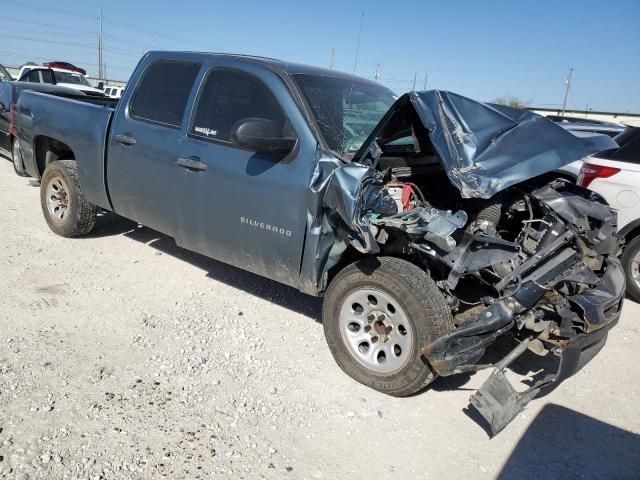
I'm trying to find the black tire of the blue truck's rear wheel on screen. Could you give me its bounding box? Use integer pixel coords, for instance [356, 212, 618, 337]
[40, 160, 97, 237]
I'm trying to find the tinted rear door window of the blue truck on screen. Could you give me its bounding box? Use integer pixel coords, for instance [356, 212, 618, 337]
[130, 60, 201, 128]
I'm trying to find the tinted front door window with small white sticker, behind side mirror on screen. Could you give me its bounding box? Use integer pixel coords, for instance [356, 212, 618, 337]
[189, 69, 292, 143]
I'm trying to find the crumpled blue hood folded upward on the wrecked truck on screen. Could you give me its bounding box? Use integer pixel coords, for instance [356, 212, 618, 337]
[356, 90, 616, 198]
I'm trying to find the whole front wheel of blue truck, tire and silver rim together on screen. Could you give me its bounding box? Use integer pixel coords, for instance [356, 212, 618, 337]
[322, 257, 454, 397]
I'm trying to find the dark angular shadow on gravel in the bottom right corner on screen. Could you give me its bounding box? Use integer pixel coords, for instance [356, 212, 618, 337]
[497, 403, 640, 480]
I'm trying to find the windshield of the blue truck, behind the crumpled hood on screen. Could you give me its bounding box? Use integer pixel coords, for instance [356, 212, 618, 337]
[293, 74, 395, 156]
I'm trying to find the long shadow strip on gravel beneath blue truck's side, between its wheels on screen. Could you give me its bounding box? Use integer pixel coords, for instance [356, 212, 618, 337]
[84, 213, 322, 322]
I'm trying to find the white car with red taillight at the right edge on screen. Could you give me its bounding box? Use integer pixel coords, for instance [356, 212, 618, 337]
[578, 127, 640, 302]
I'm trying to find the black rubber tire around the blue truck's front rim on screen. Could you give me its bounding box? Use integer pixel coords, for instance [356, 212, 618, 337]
[322, 257, 455, 397]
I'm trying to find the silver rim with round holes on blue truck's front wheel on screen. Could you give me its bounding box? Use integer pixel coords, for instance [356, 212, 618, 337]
[339, 288, 414, 374]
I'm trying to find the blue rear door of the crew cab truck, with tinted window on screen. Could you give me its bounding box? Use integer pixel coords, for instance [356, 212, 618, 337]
[107, 60, 200, 236]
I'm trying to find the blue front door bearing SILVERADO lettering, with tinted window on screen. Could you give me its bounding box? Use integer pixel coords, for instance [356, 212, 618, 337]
[178, 65, 313, 286]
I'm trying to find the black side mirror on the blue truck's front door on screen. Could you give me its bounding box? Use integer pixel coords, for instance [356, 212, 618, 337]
[231, 118, 297, 154]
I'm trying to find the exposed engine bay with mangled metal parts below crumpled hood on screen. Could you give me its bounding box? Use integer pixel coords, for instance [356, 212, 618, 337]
[370, 169, 618, 352]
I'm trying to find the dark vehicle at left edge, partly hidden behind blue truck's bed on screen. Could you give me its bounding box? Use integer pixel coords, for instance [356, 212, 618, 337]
[0, 82, 85, 176]
